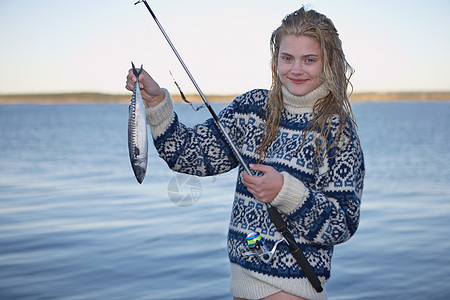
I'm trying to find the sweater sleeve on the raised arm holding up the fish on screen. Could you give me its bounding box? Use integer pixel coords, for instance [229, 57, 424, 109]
[147, 91, 238, 176]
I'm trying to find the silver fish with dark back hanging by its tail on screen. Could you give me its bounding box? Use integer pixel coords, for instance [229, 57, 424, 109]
[128, 63, 148, 183]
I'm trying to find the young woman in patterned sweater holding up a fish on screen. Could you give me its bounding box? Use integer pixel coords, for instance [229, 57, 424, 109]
[126, 8, 365, 299]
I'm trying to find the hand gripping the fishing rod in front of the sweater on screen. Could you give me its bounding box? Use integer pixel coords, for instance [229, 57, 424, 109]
[243, 164, 284, 203]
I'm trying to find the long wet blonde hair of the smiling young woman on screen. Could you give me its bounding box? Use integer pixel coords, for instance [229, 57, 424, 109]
[259, 7, 356, 161]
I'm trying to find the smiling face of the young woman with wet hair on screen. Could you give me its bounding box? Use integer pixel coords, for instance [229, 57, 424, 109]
[278, 35, 322, 96]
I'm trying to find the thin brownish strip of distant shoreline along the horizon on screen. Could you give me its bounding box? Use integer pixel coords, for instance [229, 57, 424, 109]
[0, 92, 450, 104]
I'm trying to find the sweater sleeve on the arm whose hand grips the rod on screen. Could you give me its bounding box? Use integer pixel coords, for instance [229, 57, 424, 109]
[272, 122, 365, 246]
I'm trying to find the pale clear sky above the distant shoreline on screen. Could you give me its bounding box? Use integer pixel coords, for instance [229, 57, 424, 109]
[0, 0, 450, 95]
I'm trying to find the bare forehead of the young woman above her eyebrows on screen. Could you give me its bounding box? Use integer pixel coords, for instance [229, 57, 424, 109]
[280, 34, 320, 55]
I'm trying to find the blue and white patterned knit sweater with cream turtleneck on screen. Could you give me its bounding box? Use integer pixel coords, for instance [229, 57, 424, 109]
[147, 85, 365, 299]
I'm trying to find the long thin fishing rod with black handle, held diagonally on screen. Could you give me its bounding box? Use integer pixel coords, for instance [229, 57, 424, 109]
[135, 0, 323, 293]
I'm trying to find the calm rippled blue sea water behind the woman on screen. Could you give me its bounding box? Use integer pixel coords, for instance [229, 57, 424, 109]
[0, 101, 450, 300]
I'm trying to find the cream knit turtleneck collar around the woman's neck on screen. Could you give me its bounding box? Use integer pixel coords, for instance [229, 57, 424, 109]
[281, 84, 330, 113]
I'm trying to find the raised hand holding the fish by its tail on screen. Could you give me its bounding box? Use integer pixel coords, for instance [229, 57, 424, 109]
[125, 69, 164, 107]
